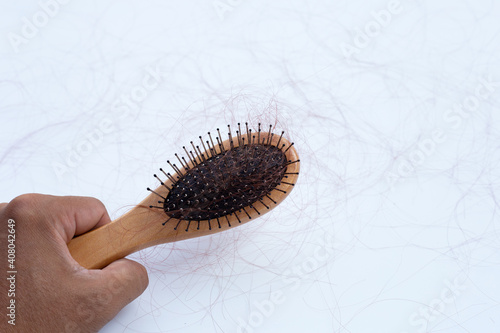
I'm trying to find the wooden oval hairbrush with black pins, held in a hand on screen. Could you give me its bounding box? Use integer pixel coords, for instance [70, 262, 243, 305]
[68, 123, 300, 269]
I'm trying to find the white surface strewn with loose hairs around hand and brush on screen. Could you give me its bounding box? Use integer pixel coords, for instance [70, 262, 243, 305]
[0, 0, 500, 333]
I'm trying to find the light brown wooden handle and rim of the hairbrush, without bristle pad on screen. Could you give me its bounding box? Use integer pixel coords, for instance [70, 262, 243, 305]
[68, 133, 300, 269]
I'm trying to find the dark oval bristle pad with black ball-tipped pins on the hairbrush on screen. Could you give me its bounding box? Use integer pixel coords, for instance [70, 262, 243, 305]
[152, 123, 299, 231]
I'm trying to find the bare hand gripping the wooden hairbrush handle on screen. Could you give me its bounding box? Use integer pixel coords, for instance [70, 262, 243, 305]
[0, 194, 148, 333]
